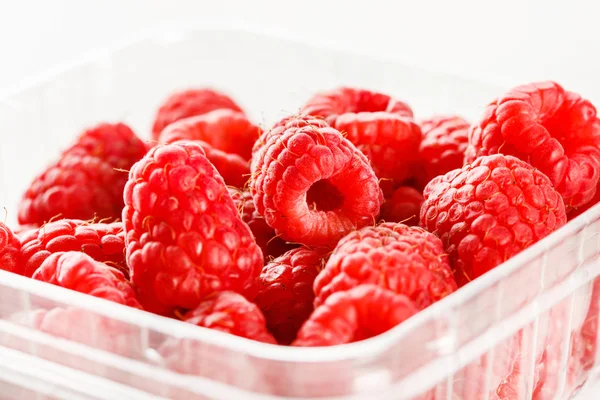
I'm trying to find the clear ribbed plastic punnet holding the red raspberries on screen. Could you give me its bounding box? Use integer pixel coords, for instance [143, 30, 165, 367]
[0, 28, 600, 400]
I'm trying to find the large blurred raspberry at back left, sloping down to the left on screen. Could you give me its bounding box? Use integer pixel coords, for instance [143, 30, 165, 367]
[19, 123, 147, 226]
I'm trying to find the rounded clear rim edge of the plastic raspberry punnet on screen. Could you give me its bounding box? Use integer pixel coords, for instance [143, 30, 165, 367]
[0, 21, 600, 363]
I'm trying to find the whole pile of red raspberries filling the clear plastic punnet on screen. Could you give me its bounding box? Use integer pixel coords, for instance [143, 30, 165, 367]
[0, 82, 600, 399]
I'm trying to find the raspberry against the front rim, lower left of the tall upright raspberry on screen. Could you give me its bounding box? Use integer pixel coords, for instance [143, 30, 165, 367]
[32, 251, 141, 308]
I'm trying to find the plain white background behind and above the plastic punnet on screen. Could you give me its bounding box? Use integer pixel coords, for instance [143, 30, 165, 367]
[0, 0, 600, 399]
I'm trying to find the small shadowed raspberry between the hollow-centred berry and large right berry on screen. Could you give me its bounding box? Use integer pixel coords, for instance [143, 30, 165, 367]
[379, 186, 423, 226]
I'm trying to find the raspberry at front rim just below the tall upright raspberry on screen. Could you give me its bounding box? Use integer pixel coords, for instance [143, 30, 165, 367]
[182, 291, 277, 344]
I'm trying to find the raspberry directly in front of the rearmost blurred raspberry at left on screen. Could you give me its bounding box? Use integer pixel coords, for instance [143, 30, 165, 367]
[159, 109, 261, 160]
